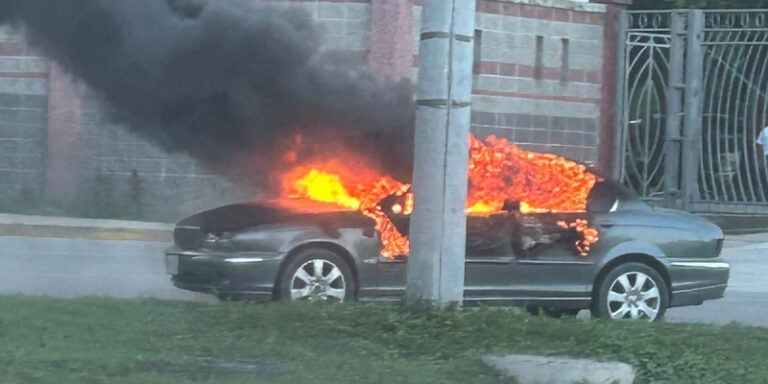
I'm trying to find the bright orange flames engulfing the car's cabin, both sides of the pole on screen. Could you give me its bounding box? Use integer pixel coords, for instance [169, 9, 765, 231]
[283, 136, 598, 258]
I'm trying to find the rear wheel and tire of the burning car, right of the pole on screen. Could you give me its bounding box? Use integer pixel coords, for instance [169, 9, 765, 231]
[591, 263, 669, 321]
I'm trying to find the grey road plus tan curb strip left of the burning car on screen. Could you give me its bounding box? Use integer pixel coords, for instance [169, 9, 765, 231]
[0, 214, 207, 300]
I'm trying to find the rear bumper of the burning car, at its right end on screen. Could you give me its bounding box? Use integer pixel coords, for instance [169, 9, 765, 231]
[667, 258, 731, 307]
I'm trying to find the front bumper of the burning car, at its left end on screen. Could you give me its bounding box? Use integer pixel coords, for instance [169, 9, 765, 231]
[165, 247, 285, 300]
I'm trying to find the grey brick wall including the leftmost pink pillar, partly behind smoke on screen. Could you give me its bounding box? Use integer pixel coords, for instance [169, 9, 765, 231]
[0, 0, 370, 221]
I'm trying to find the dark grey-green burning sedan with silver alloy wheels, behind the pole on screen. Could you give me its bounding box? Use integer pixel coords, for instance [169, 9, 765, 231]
[166, 182, 730, 320]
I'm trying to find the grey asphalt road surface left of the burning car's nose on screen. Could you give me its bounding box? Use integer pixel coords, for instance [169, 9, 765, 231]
[0, 236, 212, 300]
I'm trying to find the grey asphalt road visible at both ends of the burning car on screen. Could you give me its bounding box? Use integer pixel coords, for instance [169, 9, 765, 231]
[0, 236, 768, 326]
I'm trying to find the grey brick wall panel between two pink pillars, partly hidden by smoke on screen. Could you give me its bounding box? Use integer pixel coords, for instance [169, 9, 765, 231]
[68, 1, 370, 220]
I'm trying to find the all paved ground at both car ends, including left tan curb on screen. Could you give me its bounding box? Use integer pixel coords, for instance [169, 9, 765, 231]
[0, 214, 768, 326]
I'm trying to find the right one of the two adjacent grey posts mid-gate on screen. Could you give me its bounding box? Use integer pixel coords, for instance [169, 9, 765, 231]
[681, 10, 704, 210]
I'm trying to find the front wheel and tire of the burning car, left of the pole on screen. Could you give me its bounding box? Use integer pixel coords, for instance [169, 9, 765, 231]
[278, 248, 355, 302]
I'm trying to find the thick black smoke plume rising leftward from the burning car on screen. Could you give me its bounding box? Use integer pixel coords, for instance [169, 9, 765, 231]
[0, 0, 414, 186]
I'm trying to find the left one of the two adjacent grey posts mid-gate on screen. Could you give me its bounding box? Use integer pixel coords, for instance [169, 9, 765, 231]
[664, 12, 686, 208]
